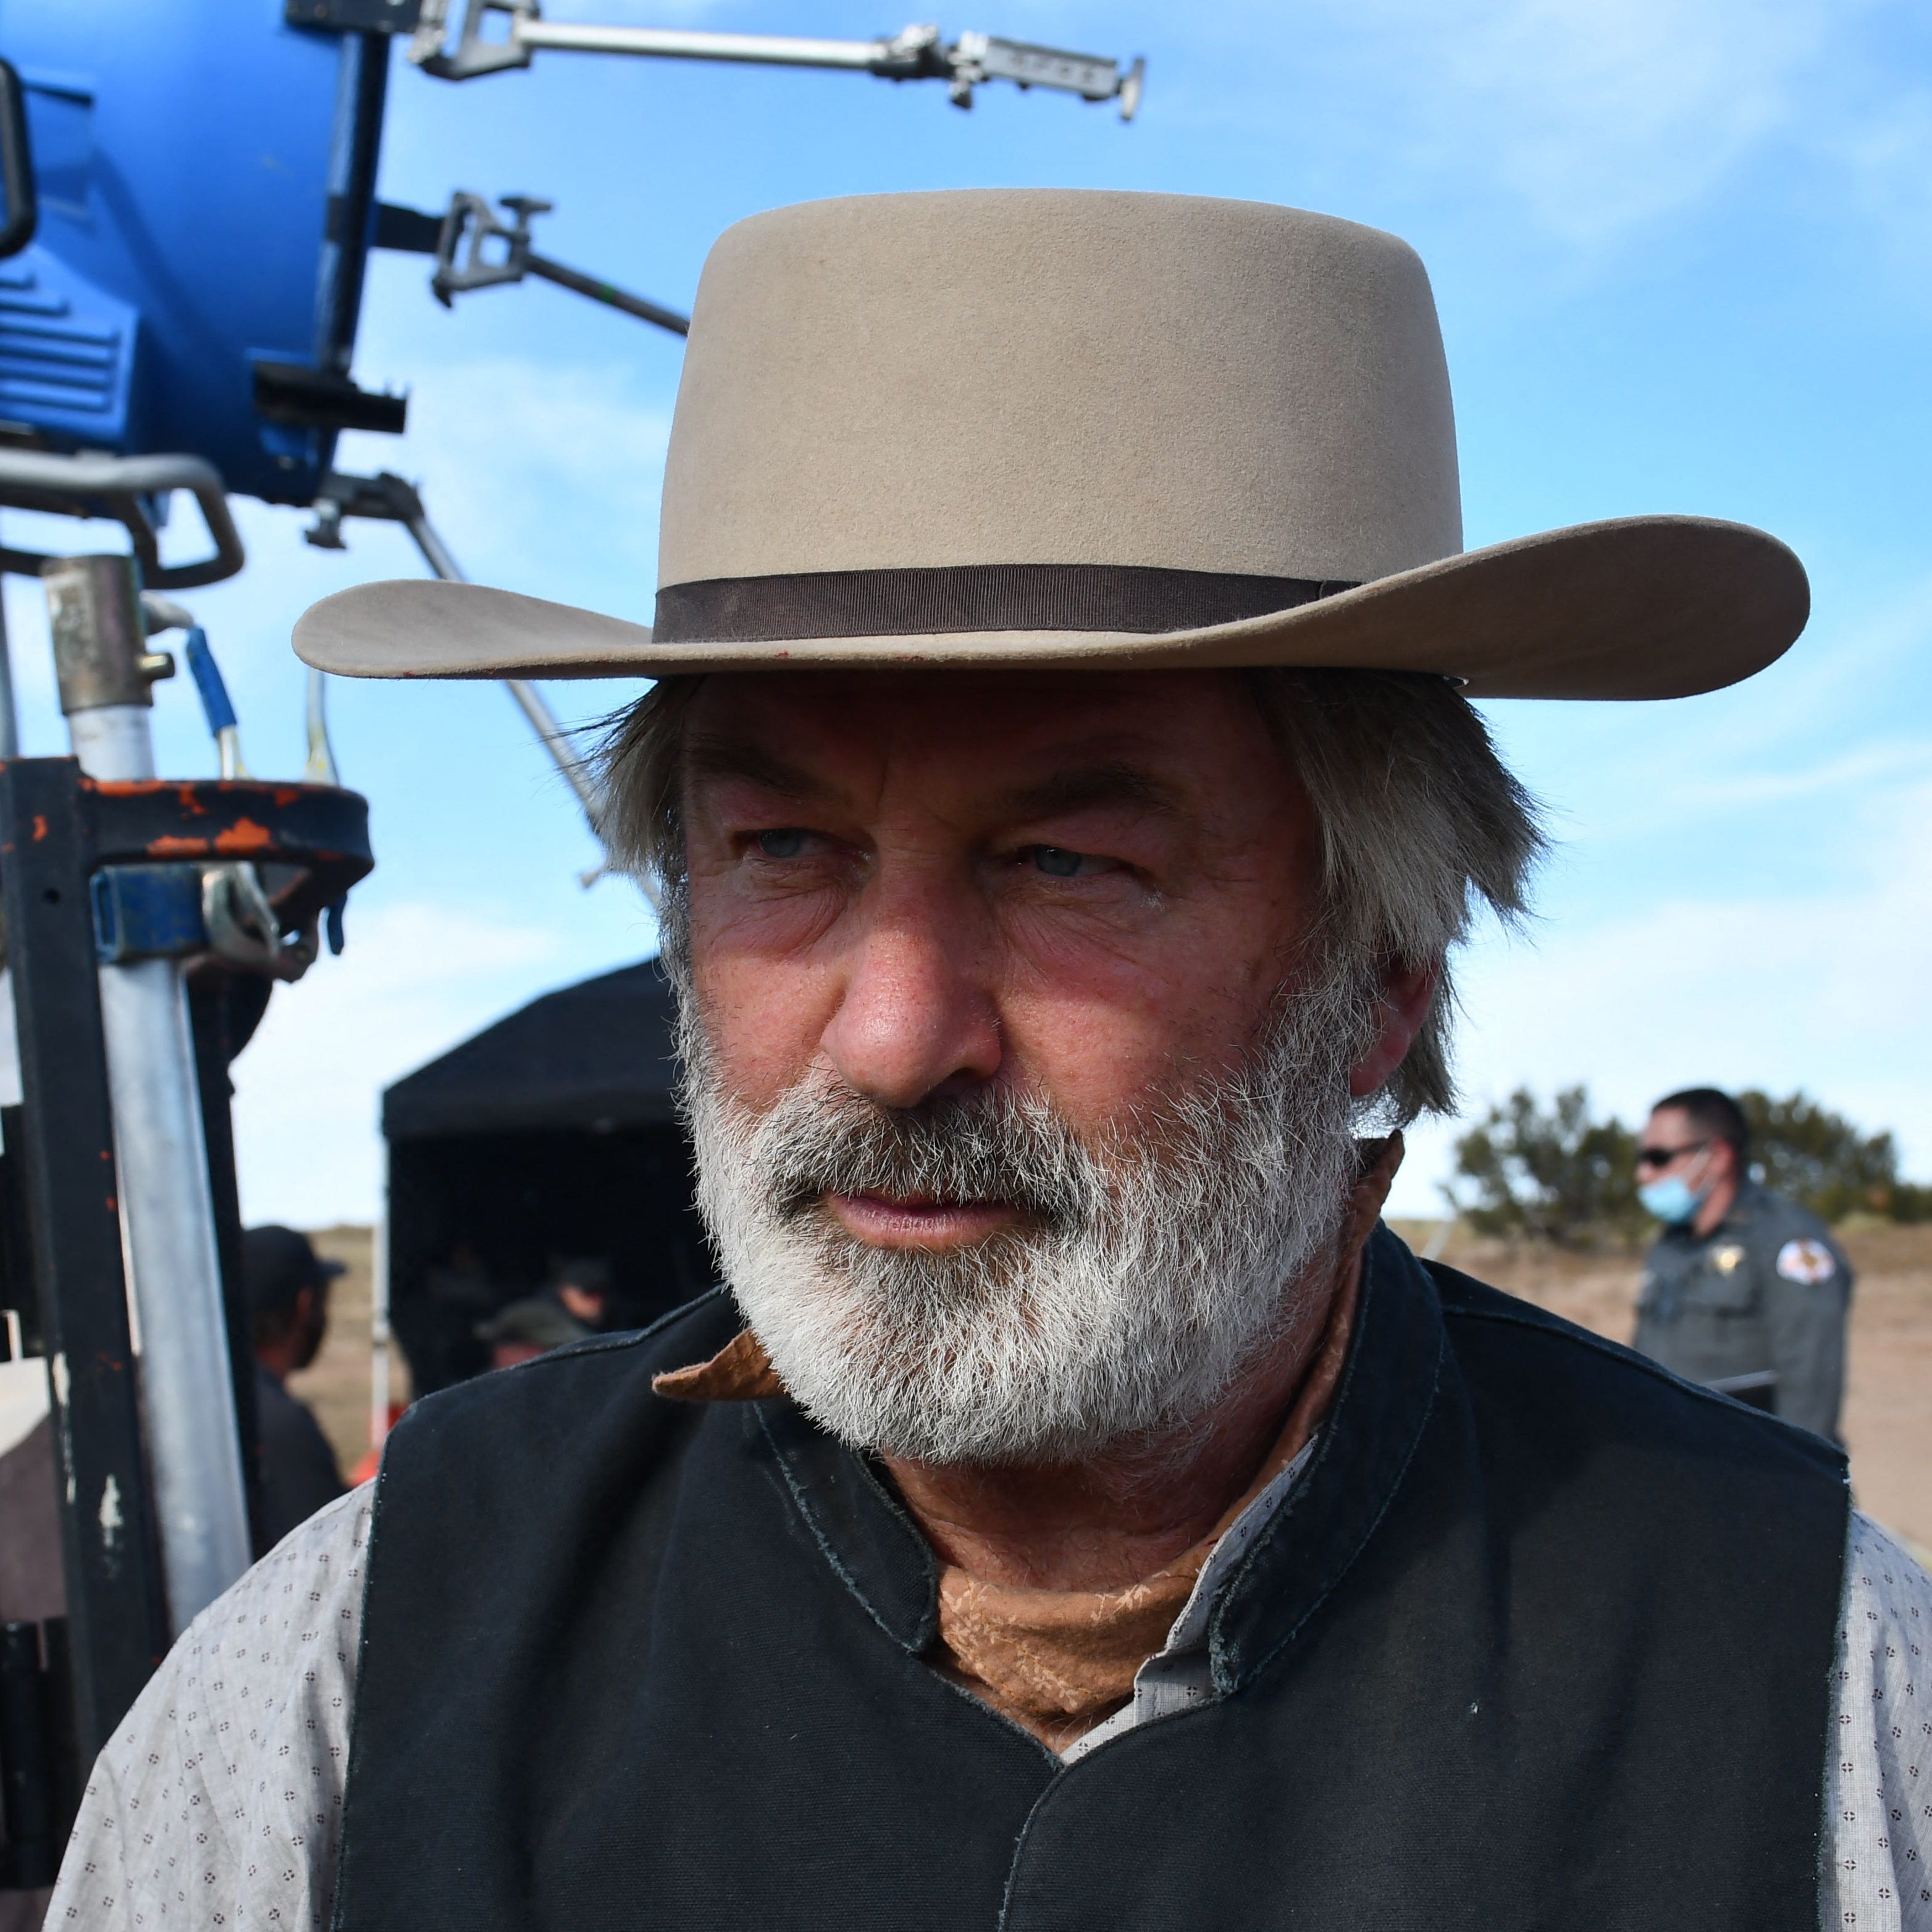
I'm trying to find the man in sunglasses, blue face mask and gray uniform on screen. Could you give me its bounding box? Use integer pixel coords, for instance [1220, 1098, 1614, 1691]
[1636, 1088, 1853, 1441]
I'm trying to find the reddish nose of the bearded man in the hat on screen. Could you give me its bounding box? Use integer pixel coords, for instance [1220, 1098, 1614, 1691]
[821, 881, 1001, 1107]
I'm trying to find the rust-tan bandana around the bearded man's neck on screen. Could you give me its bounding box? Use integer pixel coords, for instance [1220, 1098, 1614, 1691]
[651, 1134, 1403, 1750]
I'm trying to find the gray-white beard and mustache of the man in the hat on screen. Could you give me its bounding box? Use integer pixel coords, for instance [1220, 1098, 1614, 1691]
[680, 974, 1370, 1464]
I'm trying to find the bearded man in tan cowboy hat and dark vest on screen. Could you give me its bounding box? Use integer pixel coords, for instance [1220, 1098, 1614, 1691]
[54, 191, 1932, 1932]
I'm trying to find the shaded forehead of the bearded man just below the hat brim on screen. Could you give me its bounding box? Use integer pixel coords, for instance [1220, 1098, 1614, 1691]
[684, 670, 1285, 805]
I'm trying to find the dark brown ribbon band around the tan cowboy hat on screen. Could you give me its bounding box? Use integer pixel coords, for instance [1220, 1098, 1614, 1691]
[651, 564, 1354, 644]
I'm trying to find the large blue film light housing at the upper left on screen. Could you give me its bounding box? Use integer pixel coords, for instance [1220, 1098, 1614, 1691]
[0, 0, 388, 504]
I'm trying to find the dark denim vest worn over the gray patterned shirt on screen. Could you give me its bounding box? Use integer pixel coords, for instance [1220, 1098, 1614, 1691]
[336, 1231, 1847, 1932]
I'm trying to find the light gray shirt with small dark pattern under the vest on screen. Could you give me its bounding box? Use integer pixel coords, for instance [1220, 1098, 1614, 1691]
[46, 1464, 1932, 1932]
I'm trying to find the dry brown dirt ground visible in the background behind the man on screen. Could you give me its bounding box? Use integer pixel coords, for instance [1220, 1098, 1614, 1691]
[290, 1221, 1932, 1553]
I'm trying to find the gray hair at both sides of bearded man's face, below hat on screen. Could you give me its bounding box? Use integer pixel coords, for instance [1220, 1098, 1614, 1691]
[597, 668, 1545, 1127]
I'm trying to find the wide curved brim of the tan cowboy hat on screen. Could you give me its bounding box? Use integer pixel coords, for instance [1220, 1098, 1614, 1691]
[296, 516, 1810, 699]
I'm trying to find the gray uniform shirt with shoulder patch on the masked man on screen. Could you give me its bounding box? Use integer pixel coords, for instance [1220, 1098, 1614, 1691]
[1636, 1184, 1853, 1441]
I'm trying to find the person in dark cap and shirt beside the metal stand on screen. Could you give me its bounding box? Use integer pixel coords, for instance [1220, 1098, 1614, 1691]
[242, 1227, 344, 1545]
